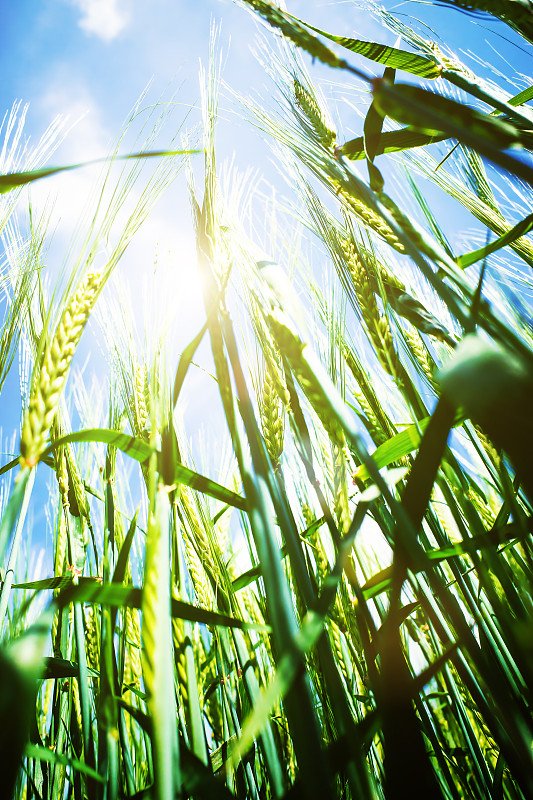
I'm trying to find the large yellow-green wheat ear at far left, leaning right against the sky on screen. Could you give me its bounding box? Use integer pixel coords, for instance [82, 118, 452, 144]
[20, 273, 104, 467]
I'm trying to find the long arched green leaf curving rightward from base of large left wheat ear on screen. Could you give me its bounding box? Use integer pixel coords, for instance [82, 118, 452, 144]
[40, 428, 246, 511]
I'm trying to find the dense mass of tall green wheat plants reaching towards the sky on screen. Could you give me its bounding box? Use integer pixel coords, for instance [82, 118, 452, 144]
[0, 0, 533, 800]
